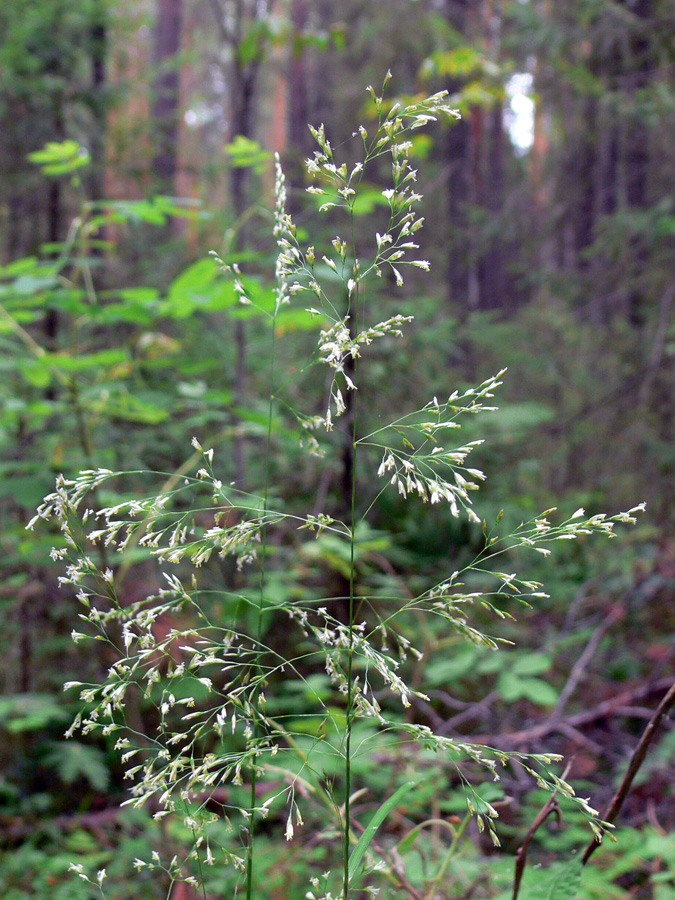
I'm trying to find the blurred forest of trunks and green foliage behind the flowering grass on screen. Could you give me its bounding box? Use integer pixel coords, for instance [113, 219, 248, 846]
[0, 0, 675, 900]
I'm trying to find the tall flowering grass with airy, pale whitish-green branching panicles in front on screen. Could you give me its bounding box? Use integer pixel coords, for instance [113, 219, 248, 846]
[29, 75, 640, 900]
